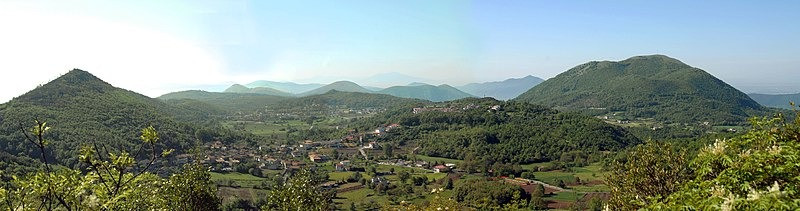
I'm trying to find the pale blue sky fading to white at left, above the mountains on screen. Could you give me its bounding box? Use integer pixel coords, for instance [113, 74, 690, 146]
[0, 0, 800, 102]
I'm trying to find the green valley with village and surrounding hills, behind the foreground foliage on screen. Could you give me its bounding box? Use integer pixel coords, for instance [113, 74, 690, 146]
[0, 55, 788, 210]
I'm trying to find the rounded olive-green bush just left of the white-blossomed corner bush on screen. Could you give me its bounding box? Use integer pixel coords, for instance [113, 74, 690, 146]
[605, 141, 691, 210]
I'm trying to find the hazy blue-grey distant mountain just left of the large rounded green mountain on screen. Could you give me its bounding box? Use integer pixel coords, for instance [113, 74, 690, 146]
[457, 75, 544, 100]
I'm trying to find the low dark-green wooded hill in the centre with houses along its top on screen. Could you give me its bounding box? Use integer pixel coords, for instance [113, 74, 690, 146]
[360, 98, 642, 163]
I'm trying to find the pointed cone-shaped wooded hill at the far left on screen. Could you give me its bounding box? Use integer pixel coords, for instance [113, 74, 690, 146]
[0, 69, 202, 170]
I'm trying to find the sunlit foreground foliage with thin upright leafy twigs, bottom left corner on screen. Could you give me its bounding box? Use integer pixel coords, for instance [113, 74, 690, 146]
[0, 121, 219, 210]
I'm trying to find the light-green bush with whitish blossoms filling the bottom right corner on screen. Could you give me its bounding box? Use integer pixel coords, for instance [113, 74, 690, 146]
[649, 111, 800, 210]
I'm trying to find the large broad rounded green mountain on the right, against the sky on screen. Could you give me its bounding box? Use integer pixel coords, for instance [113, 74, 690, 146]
[515, 55, 767, 124]
